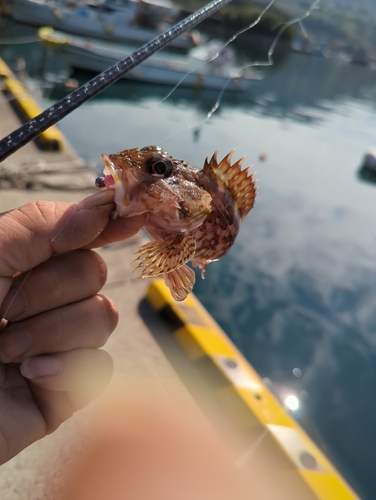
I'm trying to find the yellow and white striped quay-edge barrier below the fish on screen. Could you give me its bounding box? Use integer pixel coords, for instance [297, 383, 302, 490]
[147, 279, 358, 500]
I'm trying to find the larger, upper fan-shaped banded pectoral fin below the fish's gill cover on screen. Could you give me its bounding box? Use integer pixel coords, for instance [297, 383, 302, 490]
[133, 233, 196, 278]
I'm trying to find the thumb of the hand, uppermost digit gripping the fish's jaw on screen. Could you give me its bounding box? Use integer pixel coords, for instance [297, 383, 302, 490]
[0, 190, 113, 304]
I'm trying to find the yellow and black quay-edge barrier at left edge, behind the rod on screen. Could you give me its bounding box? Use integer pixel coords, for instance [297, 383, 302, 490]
[0, 58, 64, 151]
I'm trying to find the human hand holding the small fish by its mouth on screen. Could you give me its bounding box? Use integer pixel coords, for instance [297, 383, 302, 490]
[0, 191, 145, 464]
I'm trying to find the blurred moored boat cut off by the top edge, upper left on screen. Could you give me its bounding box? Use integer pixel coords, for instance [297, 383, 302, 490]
[9, 0, 196, 50]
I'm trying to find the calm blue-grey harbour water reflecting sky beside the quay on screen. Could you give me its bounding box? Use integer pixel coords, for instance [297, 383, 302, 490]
[0, 16, 376, 499]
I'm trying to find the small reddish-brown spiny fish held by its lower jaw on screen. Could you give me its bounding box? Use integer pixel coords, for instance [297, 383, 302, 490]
[96, 146, 256, 300]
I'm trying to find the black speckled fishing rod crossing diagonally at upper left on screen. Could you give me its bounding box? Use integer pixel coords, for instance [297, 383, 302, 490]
[0, 0, 231, 162]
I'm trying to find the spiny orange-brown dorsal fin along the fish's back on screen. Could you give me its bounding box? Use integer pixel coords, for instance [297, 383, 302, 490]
[204, 149, 257, 219]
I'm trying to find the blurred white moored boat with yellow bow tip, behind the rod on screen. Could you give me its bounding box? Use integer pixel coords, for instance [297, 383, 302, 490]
[39, 28, 260, 91]
